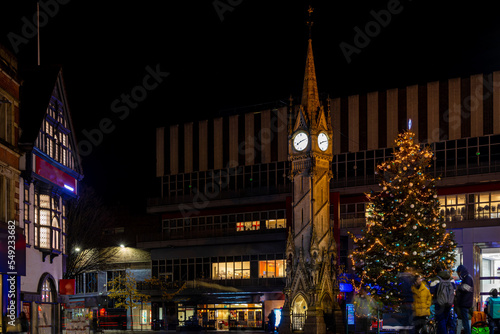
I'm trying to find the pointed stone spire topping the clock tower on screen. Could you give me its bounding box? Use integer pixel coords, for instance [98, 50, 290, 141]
[301, 6, 319, 115]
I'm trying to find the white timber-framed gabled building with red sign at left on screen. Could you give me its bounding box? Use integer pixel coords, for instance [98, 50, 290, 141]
[19, 67, 83, 333]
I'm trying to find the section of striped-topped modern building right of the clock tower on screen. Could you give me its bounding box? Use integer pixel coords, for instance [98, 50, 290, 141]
[331, 72, 500, 308]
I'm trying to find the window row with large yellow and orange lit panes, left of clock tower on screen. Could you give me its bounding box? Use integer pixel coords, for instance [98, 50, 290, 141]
[152, 254, 286, 282]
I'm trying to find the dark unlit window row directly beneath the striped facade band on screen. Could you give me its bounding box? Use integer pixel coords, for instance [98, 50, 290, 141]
[163, 135, 500, 197]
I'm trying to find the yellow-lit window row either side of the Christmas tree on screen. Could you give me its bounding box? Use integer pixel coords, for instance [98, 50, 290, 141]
[340, 191, 500, 227]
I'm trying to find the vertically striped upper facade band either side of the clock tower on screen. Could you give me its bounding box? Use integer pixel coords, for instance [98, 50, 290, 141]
[156, 72, 500, 183]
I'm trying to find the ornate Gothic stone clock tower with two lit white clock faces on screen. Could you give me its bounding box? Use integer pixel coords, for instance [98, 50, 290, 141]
[280, 8, 343, 333]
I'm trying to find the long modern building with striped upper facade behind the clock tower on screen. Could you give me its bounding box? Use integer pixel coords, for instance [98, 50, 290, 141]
[138, 36, 500, 329]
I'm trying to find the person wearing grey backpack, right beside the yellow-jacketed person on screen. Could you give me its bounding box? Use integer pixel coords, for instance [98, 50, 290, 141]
[430, 267, 456, 334]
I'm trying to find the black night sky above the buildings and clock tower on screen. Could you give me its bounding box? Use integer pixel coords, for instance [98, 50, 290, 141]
[0, 0, 500, 211]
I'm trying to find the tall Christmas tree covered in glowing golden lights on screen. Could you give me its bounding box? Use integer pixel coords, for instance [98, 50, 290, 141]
[351, 126, 456, 306]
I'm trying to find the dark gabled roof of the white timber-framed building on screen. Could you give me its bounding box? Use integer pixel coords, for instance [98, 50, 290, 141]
[19, 66, 83, 175]
